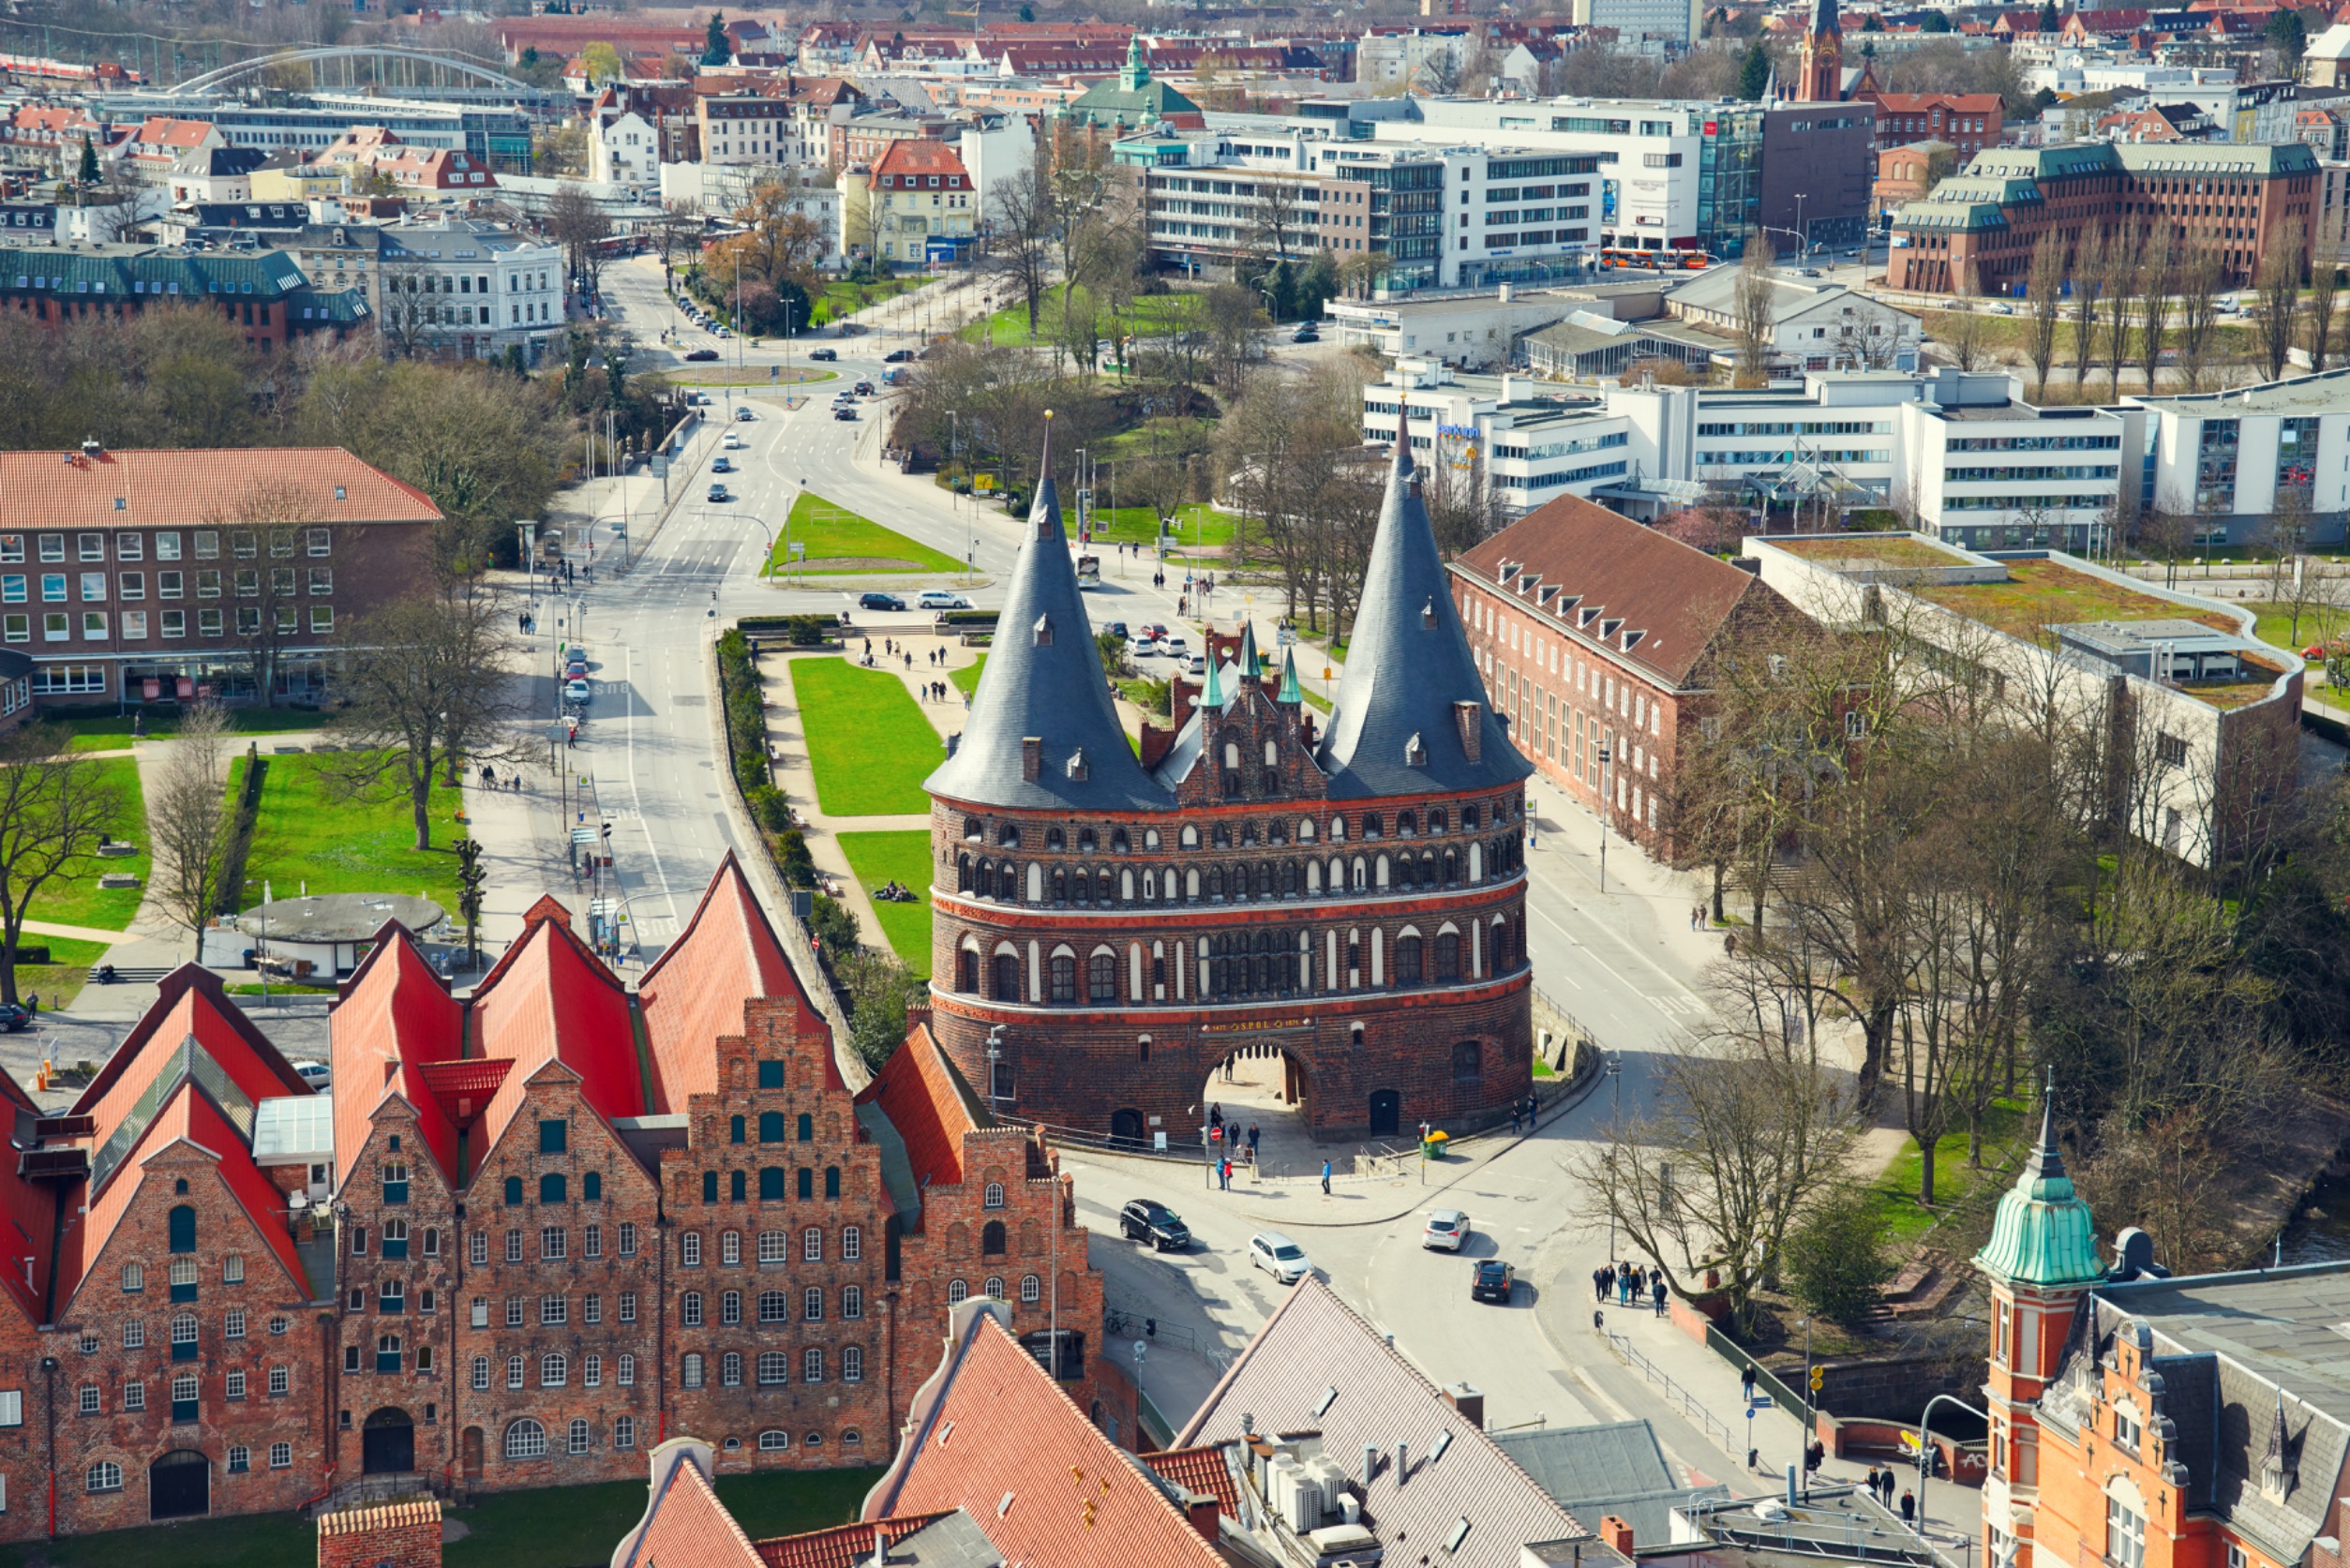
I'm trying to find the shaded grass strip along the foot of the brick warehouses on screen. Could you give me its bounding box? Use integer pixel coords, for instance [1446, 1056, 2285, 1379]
[0, 1470, 879, 1568]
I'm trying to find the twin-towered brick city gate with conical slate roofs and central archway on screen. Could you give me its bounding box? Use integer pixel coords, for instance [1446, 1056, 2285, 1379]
[928, 413, 1533, 1142]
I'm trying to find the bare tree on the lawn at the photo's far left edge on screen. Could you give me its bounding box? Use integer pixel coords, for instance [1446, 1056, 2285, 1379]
[0, 724, 125, 1002]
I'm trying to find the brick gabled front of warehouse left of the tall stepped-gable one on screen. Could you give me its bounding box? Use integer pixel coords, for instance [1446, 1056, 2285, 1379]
[448, 1065, 660, 1490]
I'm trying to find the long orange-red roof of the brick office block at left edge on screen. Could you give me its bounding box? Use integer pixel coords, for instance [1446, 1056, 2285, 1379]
[0, 447, 440, 529]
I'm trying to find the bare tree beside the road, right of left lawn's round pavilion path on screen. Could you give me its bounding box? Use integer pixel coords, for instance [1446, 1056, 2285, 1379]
[331, 578, 522, 848]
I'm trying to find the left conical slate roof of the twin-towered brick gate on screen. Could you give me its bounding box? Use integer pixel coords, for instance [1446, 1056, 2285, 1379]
[923, 438, 1175, 811]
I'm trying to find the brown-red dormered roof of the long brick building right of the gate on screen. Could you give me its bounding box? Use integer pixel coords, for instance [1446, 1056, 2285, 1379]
[1452, 496, 1781, 686]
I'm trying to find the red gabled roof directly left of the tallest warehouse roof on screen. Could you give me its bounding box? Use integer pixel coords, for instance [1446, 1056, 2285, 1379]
[472, 898, 644, 1150]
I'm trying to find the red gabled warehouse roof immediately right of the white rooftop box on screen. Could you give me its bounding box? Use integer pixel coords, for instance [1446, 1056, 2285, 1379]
[329, 921, 460, 1187]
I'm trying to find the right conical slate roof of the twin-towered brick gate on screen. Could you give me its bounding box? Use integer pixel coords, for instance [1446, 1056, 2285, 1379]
[1316, 409, 1534, 799]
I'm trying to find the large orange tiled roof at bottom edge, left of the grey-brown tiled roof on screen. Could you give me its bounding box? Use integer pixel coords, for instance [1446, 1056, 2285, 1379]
[865, 1303, 1224, 1568]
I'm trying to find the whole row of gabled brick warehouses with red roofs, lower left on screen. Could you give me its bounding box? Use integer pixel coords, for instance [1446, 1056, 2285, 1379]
[0, 860, 1135, 1540]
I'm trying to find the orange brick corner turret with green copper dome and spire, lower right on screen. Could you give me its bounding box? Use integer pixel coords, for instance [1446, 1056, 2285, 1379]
[1974, 1083, 2105, 1568]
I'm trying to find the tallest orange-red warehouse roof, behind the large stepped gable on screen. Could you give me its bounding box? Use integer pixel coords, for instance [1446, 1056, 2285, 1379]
[636, 851, 839, 1114]
